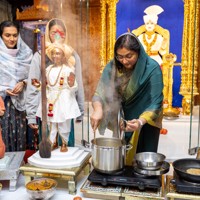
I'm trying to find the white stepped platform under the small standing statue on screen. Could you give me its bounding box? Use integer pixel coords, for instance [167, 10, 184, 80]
[28, 147, 90, 169]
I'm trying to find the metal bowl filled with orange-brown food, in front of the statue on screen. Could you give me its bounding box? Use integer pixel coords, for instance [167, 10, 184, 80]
[26, 178, 57, 200]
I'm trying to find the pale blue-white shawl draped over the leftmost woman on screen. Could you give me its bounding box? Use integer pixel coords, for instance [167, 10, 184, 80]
[0, 35, 32, 111]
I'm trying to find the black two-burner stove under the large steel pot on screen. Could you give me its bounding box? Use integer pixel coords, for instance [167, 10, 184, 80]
[88, 166, 162, 190]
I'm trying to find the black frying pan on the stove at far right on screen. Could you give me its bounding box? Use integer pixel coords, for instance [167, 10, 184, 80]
[172, 158, 200, 183]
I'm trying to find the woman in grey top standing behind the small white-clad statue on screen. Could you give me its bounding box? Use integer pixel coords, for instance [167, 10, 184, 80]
[26, 18, 84, 146]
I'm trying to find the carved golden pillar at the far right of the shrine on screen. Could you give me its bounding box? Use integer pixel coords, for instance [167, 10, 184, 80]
[180, 0, 199, 114]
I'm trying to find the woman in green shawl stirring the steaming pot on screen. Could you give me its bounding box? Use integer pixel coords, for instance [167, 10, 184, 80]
[90, 33, 163, 165]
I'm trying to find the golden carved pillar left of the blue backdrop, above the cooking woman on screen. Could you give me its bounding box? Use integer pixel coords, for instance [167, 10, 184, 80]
[100, 0, 119, 72]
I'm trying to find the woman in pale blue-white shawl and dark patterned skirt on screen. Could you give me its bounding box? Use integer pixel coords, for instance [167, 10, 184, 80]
[0, 21, 32, 151]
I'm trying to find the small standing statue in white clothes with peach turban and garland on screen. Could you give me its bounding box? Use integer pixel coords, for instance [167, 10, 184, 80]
[32, 43, 81, 152]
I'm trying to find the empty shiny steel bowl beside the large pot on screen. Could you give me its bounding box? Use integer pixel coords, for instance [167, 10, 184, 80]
[135, 152, 166, 170]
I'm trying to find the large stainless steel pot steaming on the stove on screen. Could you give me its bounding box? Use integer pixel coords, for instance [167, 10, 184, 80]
[91, 138, 130, 174]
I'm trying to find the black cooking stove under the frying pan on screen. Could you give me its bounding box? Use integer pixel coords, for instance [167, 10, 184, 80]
[171, 172, 200, 194]
